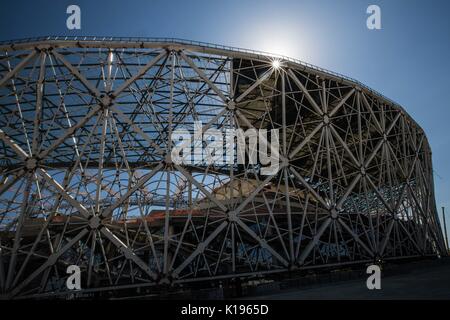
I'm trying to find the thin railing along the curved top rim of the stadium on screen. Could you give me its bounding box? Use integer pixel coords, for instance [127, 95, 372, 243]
[0, 36, 400, 107]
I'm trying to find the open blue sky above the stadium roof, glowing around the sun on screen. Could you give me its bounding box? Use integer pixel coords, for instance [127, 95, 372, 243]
[0, 0, 450, 240]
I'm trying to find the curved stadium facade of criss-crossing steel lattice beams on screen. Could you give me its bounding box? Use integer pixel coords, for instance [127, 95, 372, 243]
[0, 38, 445, 298]
